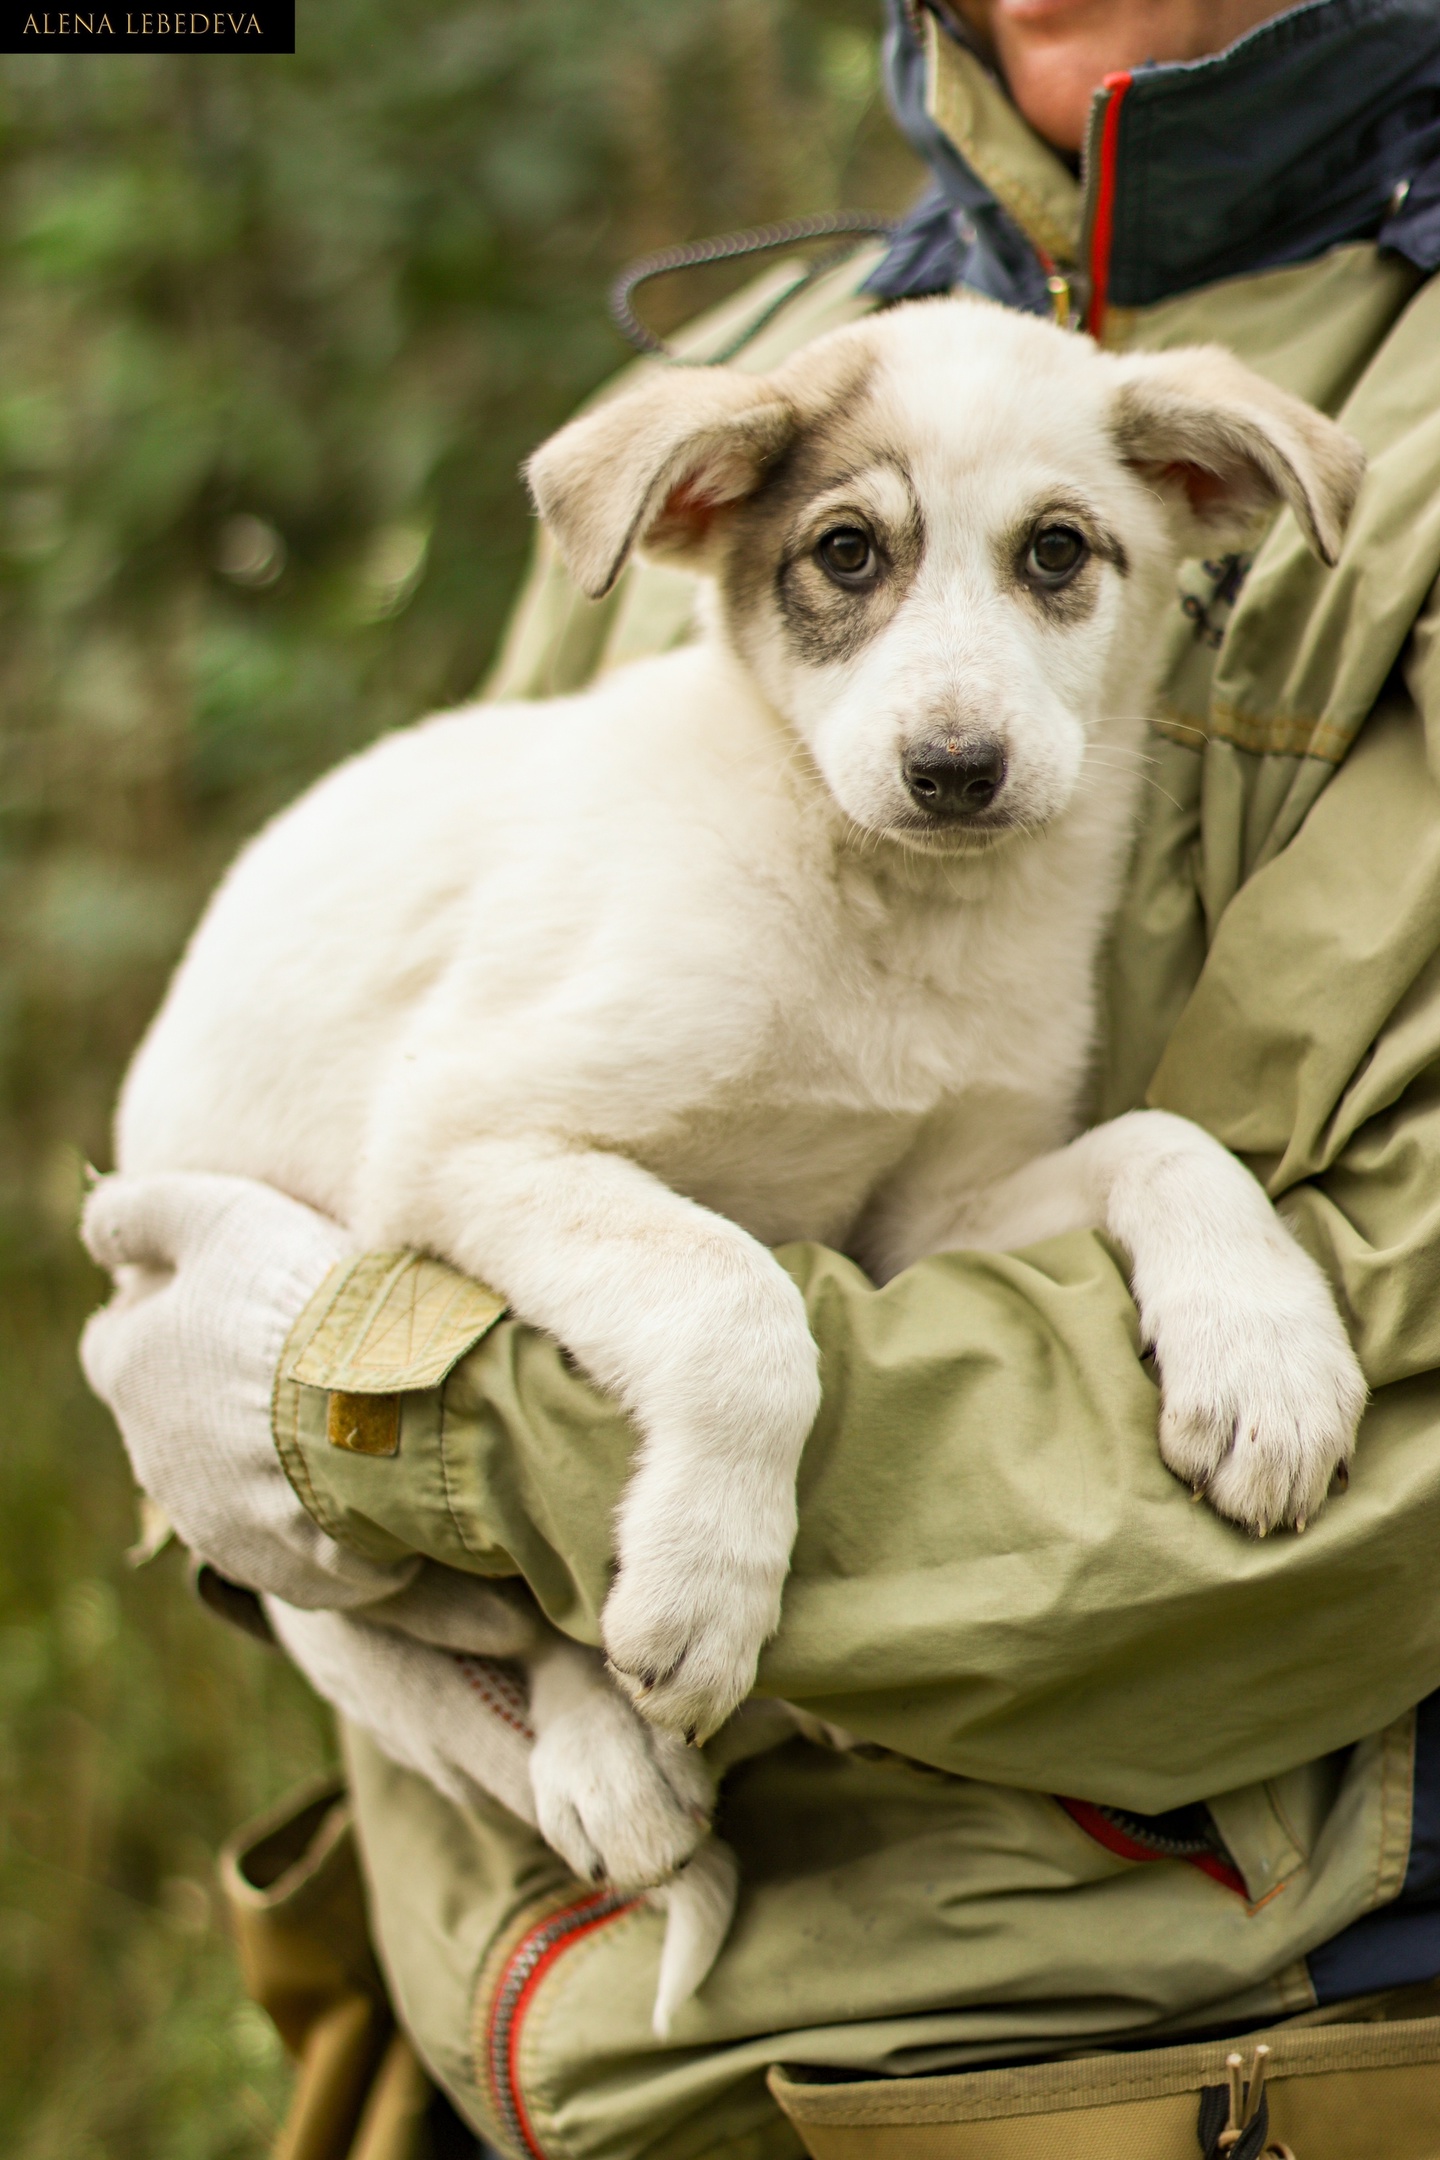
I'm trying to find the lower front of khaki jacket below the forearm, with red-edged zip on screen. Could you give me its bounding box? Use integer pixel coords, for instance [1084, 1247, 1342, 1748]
[348, 1730, 1434, 2160]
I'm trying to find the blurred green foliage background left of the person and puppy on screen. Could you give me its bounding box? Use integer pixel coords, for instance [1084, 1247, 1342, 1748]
[0, 0, 920, 2160]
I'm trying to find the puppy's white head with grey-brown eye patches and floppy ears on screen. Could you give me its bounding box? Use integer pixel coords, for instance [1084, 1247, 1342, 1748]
[529, 300, 1362, 851]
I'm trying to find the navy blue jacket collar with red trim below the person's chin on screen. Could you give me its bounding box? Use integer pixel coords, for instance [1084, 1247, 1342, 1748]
[870, 0, 1440, 313]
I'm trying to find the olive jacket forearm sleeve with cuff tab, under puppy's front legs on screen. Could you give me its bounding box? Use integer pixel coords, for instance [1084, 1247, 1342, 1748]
[276, 1175, 1440, 1810]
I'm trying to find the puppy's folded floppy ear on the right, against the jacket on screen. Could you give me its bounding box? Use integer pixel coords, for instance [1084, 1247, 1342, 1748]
[1112, 346, 1364, 562]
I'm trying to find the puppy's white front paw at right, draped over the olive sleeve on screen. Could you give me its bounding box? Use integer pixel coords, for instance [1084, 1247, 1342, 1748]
[1142, 1225, 1364, 1536]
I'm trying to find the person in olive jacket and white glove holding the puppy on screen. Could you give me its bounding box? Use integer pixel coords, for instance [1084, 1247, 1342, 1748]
[84, 0, 1440, 2160]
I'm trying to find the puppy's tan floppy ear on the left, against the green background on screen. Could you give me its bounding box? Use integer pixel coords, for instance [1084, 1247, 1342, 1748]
[525, 367, 797, 600]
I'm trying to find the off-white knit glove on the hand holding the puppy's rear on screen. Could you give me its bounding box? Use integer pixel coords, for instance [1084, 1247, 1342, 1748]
[80, 1173, 419, 1607]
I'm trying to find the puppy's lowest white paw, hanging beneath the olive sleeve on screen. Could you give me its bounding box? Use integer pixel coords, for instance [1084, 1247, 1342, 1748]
[529, 1689, 715, 1890]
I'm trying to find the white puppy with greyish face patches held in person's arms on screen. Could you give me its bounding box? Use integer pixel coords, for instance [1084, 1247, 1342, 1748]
[119, 300, 1364, 2013]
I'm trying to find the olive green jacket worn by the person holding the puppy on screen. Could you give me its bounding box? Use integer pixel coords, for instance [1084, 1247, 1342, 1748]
[264, 45, 1440, 2154]
